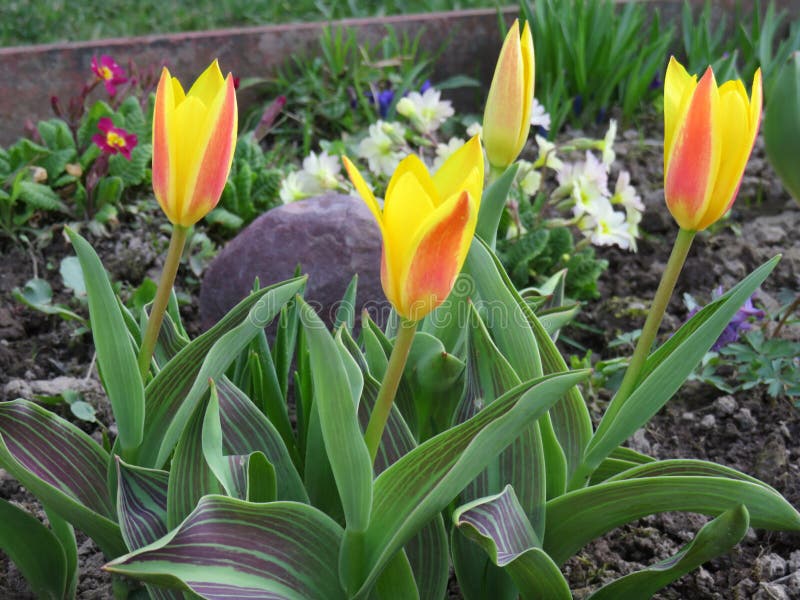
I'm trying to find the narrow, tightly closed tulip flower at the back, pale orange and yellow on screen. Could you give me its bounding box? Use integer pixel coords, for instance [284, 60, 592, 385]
[483, 21, 535, 170]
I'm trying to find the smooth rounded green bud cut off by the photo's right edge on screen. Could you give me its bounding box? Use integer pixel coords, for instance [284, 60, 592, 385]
[764, 52, 800, 202]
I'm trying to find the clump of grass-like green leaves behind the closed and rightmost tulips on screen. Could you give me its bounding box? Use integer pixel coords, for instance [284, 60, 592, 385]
[521, 0, 674, 136]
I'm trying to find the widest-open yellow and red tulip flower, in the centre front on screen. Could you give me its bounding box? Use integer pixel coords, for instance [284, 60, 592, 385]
[343, 136, 483, 321]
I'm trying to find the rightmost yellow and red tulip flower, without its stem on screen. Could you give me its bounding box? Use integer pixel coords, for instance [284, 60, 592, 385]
[664, 58, 762, 231]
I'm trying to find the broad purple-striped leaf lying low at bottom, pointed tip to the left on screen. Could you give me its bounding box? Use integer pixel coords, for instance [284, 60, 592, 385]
[104, 496, 345, 600]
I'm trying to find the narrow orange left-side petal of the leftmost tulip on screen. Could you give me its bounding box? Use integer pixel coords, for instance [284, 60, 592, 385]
[152, 67, 175, 221]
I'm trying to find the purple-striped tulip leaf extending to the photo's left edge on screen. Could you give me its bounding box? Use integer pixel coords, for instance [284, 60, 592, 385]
[0, 400, 126, 556]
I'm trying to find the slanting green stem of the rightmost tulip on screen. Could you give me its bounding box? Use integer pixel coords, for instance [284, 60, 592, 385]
[614, 229, 697, 406]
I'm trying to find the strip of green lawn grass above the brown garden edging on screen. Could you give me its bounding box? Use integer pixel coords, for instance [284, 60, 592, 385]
[0, 0, 498, 46]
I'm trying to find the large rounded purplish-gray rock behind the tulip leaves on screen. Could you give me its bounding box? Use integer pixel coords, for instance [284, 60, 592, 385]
[200, 194, 389, 328]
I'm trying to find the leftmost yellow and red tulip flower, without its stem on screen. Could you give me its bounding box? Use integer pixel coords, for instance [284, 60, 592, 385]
[153, 60, 238, 227]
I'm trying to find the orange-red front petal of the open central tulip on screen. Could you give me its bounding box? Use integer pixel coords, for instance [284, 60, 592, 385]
[396, 191, 478, 321]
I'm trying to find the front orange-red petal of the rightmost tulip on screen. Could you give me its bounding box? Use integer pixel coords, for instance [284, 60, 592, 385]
[664, 68, 722, 230]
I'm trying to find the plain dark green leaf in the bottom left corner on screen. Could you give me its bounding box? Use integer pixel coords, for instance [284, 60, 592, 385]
[0, 498, 71, 600]
